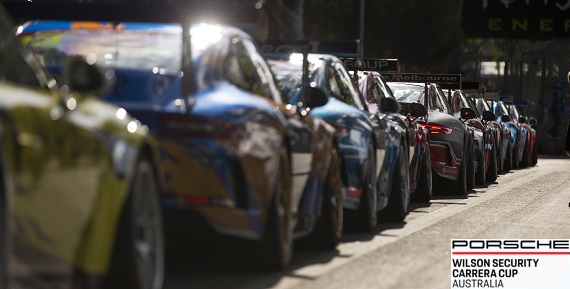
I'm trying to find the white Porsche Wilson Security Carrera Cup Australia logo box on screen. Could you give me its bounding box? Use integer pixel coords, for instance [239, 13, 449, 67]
[450, 239, 570, 289]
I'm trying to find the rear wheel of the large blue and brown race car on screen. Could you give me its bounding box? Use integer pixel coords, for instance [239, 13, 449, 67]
[261, 147, 293, 269]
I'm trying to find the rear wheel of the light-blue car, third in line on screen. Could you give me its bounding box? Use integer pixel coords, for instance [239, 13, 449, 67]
[355, 143, 378, 232]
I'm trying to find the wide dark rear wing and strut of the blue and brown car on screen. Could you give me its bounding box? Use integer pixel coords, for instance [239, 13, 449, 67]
[1, 0, 262, 109]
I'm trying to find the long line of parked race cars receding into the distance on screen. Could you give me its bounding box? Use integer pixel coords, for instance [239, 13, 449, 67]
[0, 2, 537, 288]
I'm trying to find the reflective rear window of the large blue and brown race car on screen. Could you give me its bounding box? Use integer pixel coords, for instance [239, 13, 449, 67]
[18, 21, 228, 104]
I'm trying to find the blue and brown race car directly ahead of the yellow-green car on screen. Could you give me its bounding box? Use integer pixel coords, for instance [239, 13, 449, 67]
[19, 9, 344, 268]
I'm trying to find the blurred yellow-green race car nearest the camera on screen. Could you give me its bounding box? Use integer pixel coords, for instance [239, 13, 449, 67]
[0, 6, 164, 288]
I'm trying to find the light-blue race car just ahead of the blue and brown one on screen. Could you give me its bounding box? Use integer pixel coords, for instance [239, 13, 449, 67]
[269, 54, 410, 230]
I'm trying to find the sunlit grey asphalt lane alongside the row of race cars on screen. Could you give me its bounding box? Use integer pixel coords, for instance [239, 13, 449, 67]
[165, 156, 570, 289]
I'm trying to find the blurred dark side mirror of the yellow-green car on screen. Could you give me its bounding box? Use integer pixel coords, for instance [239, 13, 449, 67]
[63, 56, 107, 96]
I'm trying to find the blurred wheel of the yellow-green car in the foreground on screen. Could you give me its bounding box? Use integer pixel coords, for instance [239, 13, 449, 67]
[104, 157, 165, 289]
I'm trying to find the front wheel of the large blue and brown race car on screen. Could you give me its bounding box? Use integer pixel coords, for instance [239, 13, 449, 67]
[305, 147, 344, 250]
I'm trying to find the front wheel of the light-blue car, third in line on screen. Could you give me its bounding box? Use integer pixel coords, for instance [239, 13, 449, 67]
[378, 144, 410, 222]
